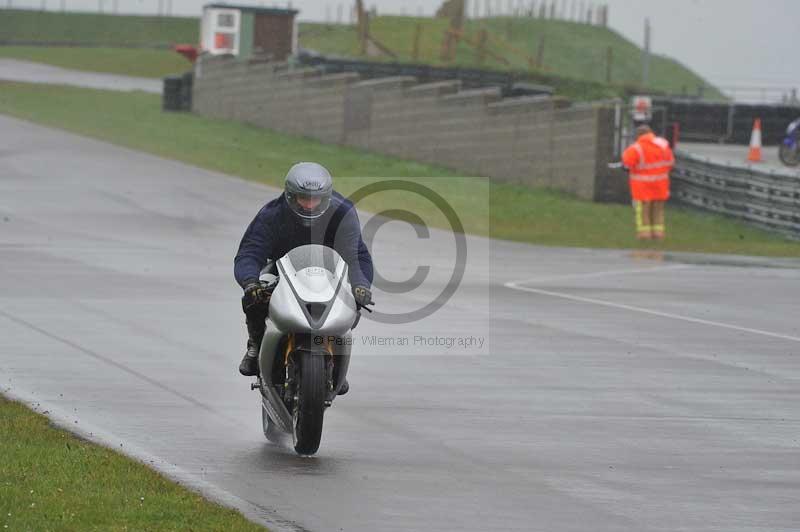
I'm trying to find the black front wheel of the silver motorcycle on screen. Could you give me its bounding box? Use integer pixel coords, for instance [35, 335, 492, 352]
[292, 352, 328, 456]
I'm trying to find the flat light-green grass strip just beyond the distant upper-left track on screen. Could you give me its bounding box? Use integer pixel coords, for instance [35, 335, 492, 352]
[0, 46, 192, 78]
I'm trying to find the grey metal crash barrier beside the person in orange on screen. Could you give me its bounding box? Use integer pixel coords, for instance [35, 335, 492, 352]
[672, 151, 800, 239]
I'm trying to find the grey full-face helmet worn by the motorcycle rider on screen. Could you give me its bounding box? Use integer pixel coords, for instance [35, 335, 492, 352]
[284, 163, 333, 227]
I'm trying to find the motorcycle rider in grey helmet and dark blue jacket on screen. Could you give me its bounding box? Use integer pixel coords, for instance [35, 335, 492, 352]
[234, 162, 373, 388]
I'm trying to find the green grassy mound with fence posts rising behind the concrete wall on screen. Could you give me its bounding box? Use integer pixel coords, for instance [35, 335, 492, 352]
[300, 16, 722, 99]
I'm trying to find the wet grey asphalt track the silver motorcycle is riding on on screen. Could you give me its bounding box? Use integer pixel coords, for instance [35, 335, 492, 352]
[0, 117, 800, 532]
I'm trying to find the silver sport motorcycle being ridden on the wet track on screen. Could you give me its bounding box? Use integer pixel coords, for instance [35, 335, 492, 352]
[252, 244, 361, 456]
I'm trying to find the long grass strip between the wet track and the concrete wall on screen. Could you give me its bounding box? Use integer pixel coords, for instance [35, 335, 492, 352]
[0, 83, 800, 257]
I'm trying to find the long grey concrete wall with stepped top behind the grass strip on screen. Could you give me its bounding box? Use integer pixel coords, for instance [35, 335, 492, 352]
[194, 56, 627, 201]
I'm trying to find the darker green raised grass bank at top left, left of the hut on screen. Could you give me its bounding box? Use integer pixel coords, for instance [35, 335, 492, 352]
[0, 9, 200, 47]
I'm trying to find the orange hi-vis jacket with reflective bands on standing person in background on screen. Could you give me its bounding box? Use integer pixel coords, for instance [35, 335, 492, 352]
[622, 133, 675, 201]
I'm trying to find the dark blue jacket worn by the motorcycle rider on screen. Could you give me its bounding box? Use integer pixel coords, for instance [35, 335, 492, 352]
[233, 192, 373, 287]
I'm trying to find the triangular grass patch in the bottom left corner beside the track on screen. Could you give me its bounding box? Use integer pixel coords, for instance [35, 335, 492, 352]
[0, 396, 265, 532]
